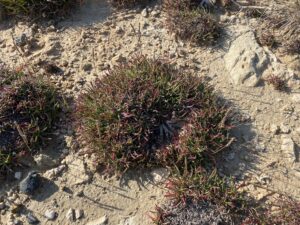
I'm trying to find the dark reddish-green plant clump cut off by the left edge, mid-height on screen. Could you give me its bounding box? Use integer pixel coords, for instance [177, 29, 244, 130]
[0, 67, 61, 173]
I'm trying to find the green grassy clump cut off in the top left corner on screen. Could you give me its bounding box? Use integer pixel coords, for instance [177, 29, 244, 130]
[0, 0, 83, 19]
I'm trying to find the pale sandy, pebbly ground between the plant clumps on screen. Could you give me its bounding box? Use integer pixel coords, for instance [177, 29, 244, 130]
[0, 0, 300, 225]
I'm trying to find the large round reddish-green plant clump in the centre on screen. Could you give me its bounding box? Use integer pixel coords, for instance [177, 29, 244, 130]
[76, 57, 231, 172]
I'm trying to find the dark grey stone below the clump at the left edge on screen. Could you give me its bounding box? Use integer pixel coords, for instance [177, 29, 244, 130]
[19, 171, 41, 195]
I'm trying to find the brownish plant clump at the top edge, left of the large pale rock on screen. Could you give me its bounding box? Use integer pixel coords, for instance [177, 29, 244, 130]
[163, 0, 221, 46]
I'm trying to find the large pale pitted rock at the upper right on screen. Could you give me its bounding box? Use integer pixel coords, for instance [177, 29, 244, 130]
[224, 31, 269, 87]
